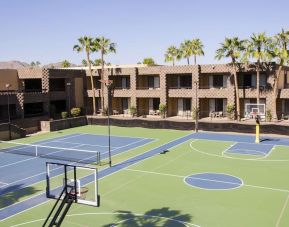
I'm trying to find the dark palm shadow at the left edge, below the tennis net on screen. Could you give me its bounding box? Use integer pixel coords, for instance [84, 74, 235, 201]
[0, 184, 40, 209]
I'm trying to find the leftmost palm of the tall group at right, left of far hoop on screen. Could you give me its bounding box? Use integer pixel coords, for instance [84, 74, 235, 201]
[215, 37, 245, 121]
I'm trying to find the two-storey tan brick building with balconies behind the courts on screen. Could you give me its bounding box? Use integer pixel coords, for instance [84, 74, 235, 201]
[0, 64, 289, 131]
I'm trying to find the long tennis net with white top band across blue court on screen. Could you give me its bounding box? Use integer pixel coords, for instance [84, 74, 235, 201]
[0, 141, 101, 165]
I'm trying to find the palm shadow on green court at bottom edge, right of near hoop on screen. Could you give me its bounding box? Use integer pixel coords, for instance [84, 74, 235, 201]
[103, 207, 192, 227]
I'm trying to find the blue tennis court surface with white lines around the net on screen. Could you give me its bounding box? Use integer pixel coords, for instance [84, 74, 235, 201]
[0, 134, 153, 195]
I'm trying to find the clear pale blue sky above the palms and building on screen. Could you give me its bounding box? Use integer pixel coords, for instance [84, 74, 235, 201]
[0, 0, 289, 64]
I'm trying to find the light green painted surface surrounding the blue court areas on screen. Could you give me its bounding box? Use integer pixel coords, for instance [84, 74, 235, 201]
[0, 126, 289, 227]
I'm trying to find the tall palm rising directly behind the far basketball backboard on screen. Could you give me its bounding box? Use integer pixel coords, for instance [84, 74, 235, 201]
[244, 32, 270, 104]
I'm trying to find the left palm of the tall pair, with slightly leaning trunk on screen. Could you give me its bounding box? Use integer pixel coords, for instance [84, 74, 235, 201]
[73, 36, 96, 115]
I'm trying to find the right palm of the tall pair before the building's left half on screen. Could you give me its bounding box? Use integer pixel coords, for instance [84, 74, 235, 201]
[93, 36, 116, 108]
